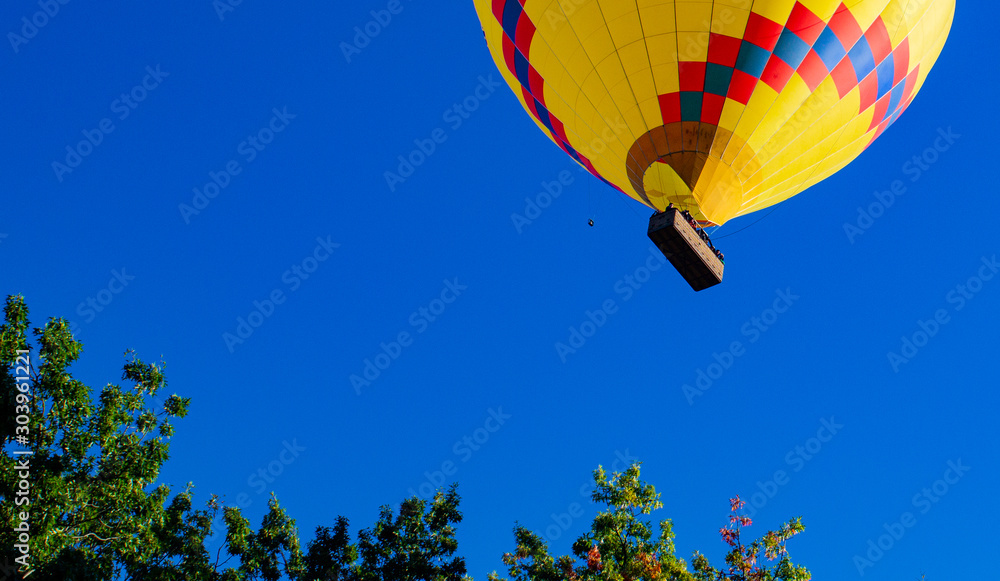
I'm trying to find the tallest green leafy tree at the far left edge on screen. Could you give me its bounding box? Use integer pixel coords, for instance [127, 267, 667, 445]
[0, 296, 195, 581]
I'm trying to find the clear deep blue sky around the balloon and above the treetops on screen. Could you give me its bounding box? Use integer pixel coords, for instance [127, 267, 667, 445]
[0, 0, 1000, 580]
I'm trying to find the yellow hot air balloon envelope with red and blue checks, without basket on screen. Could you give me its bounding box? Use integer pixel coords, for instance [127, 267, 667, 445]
[474, 0, 955, 224]
